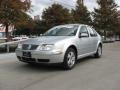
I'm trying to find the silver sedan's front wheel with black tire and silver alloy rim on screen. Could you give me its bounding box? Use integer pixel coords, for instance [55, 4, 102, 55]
[63, 48, 77, 70]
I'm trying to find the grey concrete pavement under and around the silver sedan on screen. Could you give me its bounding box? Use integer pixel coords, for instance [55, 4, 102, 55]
[0, 42, 120, 90]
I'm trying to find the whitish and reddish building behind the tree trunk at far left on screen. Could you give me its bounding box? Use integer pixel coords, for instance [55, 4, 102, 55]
[0, 24, 14, 38]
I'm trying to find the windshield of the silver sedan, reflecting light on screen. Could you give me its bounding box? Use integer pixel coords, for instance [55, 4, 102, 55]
[44, 25, 78, 36]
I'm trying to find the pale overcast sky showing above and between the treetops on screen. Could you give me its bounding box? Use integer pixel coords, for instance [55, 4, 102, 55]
[28, 0, 120, 16]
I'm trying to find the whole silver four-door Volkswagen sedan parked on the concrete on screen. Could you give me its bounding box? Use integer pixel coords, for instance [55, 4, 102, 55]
[16, 24, 102, 69]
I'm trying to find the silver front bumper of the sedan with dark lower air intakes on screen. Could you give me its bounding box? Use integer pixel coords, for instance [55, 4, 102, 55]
[16, 49, 64, 63]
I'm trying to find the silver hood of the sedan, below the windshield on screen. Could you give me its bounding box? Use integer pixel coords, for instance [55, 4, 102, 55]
[23, 36, 72, 45]
